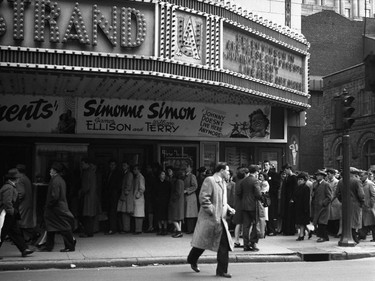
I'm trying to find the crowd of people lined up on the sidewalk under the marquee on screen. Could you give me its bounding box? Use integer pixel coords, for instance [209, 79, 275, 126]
[0, 158, 375, 256]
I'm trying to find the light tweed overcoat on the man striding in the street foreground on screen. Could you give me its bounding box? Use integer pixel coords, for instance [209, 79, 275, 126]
[191, 173, 234, 252]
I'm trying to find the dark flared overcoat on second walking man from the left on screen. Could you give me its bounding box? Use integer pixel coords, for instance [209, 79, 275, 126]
[44, 175, 74, 231]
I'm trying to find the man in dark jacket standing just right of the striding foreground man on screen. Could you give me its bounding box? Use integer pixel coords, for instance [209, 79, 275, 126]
[236, 165, 262, 251]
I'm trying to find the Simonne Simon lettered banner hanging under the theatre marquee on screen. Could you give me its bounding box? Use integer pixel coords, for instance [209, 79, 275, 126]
[77, 98, 271, 139]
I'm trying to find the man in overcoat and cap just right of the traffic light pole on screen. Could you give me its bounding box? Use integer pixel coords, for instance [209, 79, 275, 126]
[337, 167, 365, 244]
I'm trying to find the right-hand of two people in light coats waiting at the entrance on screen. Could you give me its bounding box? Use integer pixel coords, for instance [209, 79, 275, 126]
[133, 165, 146, 234]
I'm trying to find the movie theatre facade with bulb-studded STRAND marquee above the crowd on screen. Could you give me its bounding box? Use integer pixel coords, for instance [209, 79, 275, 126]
[0, 0, 309, 181]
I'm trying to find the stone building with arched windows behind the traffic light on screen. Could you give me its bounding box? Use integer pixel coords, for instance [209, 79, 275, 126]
[323, 55, 375, 170]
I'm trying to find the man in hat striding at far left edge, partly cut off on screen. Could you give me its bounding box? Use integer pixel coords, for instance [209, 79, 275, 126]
[0, 169, 34, 257]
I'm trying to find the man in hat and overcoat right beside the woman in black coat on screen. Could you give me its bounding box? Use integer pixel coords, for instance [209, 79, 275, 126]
[311, 167, 333, 242]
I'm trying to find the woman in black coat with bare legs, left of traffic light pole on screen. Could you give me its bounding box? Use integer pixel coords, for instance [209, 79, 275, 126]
[293, 172, 310, 241]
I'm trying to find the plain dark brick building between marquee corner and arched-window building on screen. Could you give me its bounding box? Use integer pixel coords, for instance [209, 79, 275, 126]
[300, 10, 375, 172]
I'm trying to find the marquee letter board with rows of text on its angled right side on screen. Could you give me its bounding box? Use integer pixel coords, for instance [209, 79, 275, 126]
[223, 26, 306, 92]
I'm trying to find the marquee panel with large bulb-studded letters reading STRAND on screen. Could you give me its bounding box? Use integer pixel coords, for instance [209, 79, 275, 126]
[0, 0, 155, 55]
